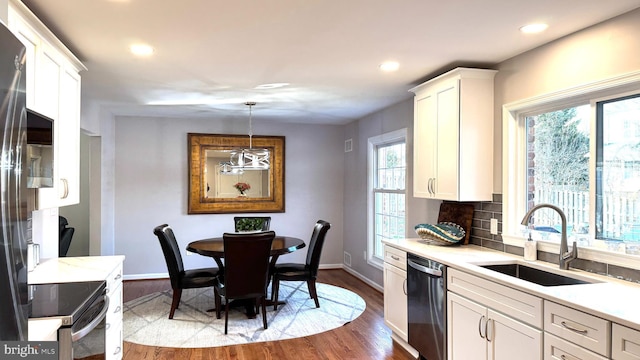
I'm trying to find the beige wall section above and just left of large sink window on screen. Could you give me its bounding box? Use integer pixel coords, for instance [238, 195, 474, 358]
[493, 9, 640, 193]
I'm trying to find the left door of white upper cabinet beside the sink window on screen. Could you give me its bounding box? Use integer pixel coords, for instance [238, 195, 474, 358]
[413, 93, 436, 198]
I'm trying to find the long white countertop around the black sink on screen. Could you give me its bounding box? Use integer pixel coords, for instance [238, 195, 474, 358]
[383, 238, 640, 330]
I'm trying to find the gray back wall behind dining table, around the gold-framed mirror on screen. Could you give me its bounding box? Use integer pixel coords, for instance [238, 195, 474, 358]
[114, 118, 344, 278]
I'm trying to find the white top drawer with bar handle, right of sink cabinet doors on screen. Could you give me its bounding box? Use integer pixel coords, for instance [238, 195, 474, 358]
[544, 301, 611, 356]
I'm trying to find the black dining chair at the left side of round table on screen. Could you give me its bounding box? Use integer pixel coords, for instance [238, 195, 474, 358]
[153, 224, 218, 319]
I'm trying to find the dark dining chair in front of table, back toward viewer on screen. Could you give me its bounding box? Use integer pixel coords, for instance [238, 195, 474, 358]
[213, 231, 276, 334]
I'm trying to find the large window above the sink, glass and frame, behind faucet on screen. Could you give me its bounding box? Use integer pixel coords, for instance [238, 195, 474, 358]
[503, 75, 640, 265]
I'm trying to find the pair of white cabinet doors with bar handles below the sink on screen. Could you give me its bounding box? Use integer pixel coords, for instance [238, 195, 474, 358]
[447, 292, 542, 360]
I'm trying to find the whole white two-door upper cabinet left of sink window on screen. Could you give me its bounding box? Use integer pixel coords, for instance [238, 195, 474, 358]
[410, 68, 496, 201]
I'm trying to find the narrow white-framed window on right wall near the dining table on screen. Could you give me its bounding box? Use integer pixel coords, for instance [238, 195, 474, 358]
[367, 129, 407, 266]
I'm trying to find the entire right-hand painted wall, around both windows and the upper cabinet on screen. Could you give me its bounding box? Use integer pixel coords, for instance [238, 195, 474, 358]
[344, 10, 640, 284]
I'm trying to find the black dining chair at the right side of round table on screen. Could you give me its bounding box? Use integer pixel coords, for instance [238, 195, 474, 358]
[272, 220, 331, 310]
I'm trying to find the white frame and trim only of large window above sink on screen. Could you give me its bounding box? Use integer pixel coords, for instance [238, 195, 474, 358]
[502, 71, 640, 267]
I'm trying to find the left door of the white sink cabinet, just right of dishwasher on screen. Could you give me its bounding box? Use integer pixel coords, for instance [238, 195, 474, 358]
[447, 292, 488, 360]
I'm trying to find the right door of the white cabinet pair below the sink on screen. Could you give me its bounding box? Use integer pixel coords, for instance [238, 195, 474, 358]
[487, 309, 542, 360]
